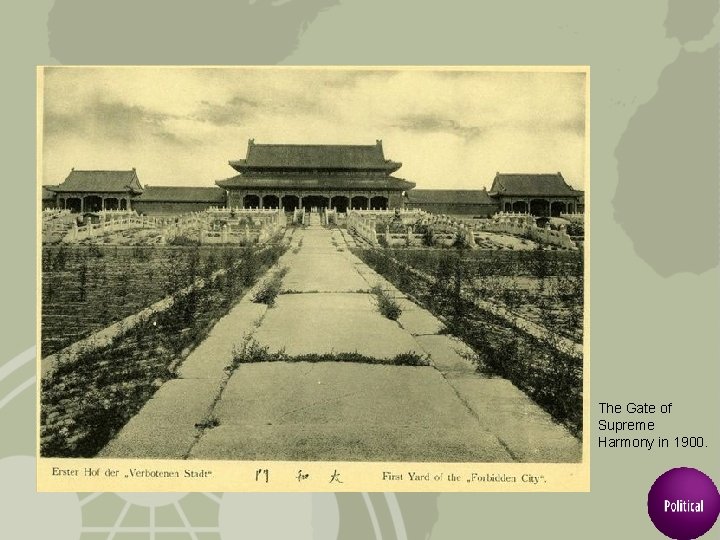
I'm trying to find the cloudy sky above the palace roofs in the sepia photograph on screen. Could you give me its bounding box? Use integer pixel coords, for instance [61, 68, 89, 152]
[42, 67, 586, 189]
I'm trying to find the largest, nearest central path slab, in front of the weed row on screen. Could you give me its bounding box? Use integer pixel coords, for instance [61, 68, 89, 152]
[191, 362, 511, 461]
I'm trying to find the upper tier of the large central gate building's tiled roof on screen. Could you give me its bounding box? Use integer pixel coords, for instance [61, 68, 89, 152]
[229, 139, 402, 172]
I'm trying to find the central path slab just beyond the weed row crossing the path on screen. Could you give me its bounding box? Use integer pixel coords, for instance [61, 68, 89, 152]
[254, 293, 423, 358]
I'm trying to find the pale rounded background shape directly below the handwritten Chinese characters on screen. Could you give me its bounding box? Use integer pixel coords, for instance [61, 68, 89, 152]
[219, 493, 340, 540]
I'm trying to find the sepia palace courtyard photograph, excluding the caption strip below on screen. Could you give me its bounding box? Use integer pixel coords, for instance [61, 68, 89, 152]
[37, 66, 589, 490]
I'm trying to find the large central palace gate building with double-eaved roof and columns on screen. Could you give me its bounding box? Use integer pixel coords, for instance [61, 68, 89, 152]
[216, 139, 415, 212]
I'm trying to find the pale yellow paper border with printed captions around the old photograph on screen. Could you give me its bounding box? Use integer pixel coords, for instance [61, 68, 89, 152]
[35, 65, 592, 492]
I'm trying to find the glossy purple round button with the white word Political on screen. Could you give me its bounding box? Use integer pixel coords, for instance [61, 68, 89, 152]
[648, 467, 720, 540]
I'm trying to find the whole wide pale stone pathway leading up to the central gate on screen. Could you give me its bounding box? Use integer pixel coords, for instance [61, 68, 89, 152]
[100, 227, 582, 462]
